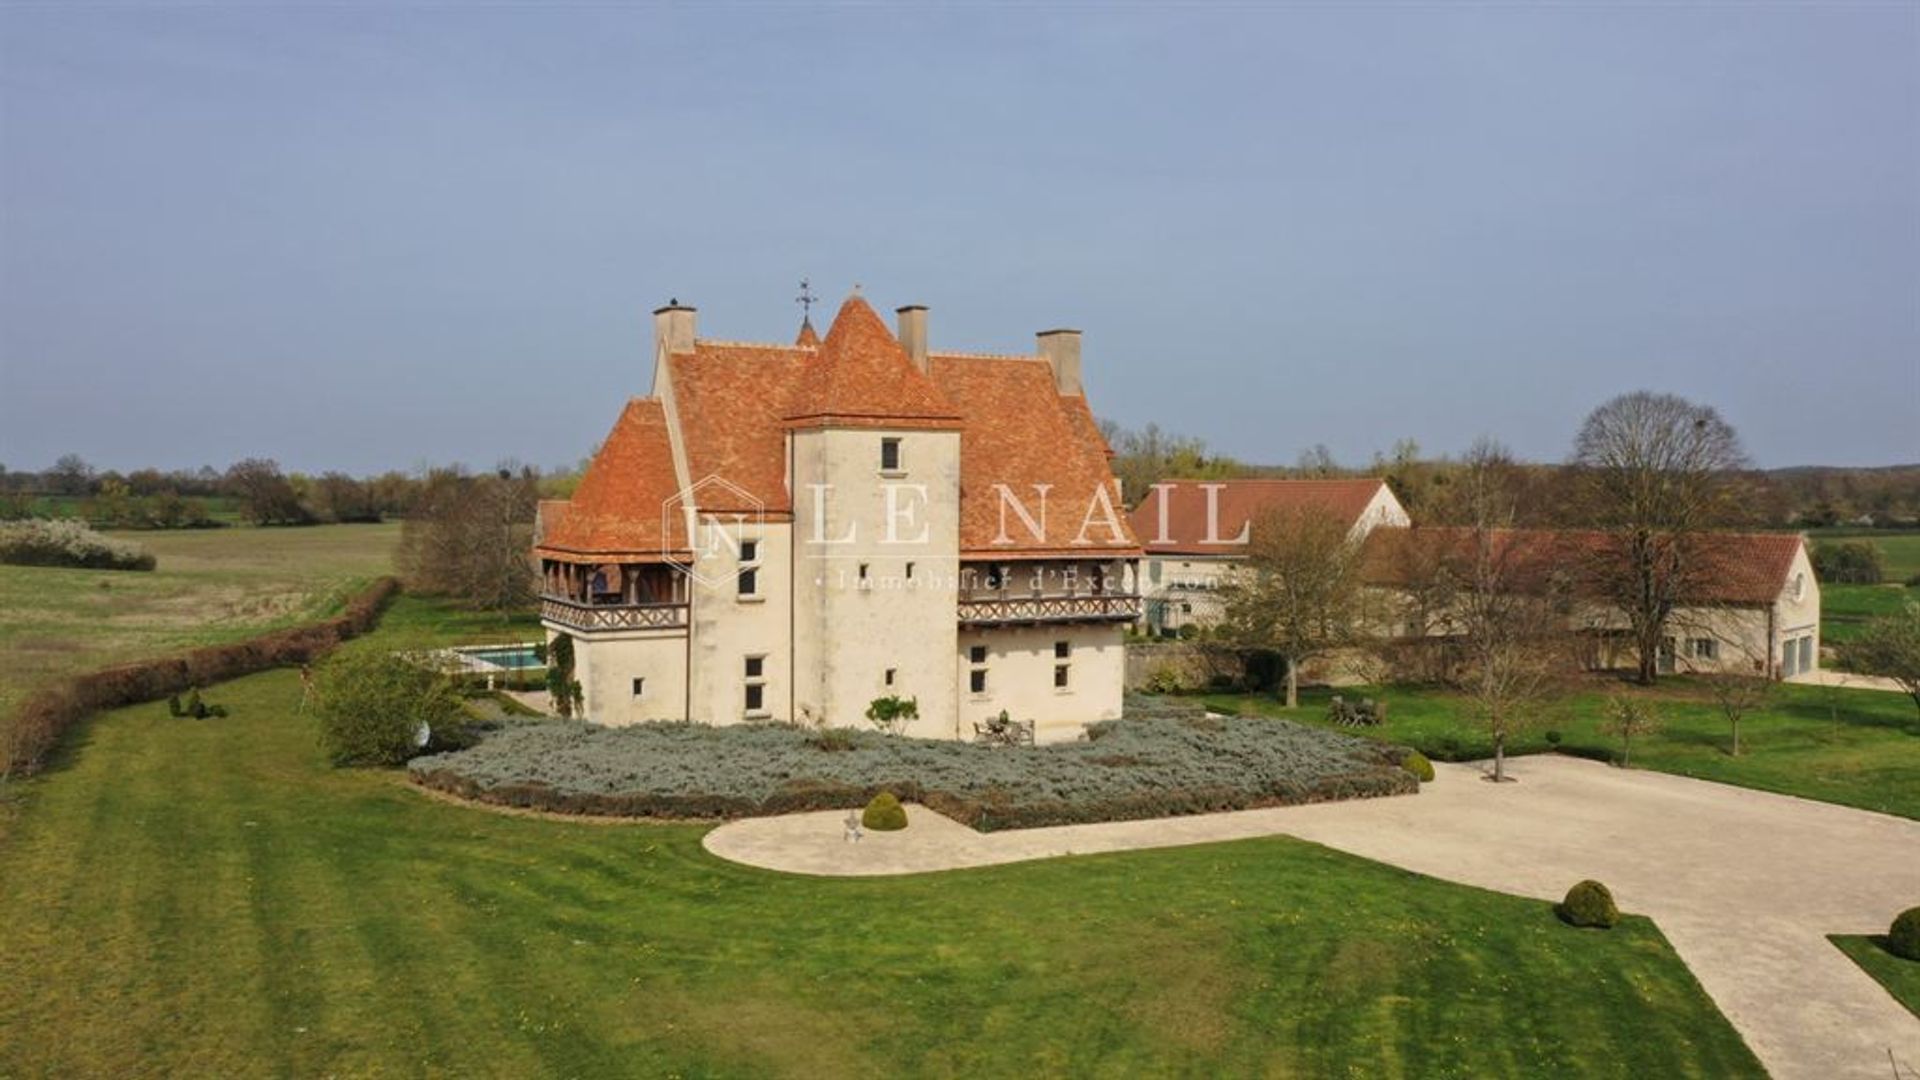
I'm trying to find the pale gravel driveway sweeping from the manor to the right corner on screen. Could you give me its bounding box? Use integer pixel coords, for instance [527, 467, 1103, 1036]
[705, 755, 1920, 1080]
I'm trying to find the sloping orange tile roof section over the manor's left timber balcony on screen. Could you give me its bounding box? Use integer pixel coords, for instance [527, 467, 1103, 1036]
[536, 398, 687, 559]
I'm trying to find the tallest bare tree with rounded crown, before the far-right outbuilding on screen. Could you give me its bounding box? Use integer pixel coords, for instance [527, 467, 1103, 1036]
[1572, 390, 1747, 684]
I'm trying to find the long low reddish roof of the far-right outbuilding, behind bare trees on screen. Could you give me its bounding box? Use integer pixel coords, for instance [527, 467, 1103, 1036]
[1361, 527, 1805, 605]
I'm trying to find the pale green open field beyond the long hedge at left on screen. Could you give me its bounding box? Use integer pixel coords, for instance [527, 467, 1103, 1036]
[0, 525, 399, 717]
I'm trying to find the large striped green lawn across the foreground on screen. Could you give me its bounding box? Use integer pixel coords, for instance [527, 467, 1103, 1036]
[0, 598, 1761, 1076]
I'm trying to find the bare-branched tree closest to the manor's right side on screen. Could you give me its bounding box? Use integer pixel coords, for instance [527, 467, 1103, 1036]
[1221, 507, 1361, 709]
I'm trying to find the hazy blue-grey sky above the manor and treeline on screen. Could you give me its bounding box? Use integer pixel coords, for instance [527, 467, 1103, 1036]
[0, 4, 1920, 473]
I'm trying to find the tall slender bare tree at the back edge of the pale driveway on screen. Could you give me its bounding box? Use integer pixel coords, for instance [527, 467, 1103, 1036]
[1448, 438, 1565, 782]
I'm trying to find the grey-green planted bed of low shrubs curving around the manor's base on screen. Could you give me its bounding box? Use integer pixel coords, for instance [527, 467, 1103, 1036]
[409, 715, 1419, 830]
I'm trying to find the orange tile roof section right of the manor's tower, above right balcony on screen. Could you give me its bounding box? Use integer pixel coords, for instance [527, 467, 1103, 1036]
[927, 354, 1139, 559]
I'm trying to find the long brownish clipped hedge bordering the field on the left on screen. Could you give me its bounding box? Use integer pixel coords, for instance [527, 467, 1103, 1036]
[0, 577, 399, 773]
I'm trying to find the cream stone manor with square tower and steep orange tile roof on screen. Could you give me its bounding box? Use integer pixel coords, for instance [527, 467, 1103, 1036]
[536, 296, 1140, 740]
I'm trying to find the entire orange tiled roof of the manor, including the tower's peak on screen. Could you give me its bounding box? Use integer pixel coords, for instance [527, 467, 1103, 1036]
[540, 298, 1139, 559]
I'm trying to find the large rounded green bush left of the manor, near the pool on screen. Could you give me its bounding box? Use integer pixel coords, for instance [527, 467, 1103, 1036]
[313, 651, 465, 765]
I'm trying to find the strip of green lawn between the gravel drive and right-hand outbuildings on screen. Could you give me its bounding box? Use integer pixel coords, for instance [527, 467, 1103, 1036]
[1208, 676, 1920, 819]
